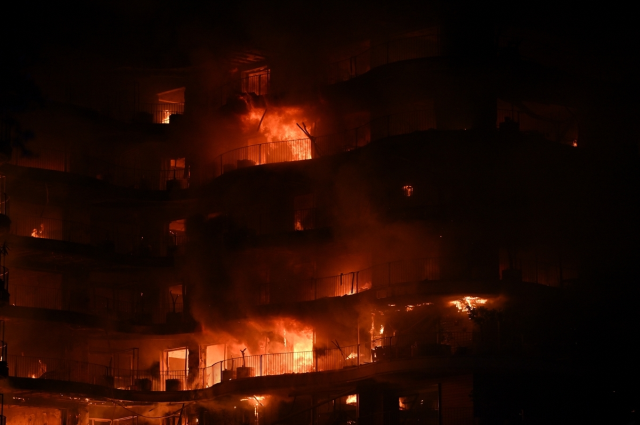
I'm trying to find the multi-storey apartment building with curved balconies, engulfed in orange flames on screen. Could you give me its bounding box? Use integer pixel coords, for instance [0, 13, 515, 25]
[0, 3, 637, 425]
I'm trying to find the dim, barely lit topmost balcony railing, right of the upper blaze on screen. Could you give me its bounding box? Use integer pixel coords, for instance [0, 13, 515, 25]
[326, 33, 440, 84]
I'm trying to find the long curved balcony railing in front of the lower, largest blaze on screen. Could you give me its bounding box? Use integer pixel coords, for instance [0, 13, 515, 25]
[8, 332, 486, 391]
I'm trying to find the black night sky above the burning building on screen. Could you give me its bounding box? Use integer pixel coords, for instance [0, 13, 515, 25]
[2, 0, 638, 84]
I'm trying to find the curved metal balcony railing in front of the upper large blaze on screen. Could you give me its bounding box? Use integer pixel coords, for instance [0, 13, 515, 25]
[206, 110, 435, 179]
